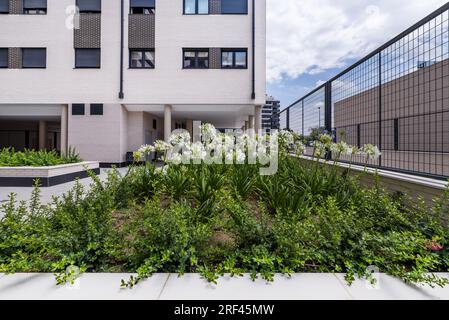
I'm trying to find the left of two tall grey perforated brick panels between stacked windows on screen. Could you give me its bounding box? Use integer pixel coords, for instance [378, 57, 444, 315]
[73, 13, 101, 49]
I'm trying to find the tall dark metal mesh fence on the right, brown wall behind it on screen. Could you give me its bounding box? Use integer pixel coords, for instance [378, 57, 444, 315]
[280, 4, 449, 178]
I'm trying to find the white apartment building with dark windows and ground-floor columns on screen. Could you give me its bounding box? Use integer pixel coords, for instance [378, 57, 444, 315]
[0, 0, 266, 166]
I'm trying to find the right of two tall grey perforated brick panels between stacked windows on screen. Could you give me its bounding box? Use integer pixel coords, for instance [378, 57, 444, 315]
[128, 14, 155, 49]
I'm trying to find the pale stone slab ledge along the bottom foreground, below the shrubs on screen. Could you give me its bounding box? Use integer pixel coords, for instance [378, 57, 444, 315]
[0, 273, 449, 300]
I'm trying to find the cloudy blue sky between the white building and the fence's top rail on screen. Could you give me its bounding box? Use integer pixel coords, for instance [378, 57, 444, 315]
[267, 0, 446, 107]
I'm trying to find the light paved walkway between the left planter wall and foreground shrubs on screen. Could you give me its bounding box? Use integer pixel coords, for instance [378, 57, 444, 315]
[0, 168, 128, 204]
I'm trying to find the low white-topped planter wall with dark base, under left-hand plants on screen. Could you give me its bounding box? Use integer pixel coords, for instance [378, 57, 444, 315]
[0, 161, 100, 187]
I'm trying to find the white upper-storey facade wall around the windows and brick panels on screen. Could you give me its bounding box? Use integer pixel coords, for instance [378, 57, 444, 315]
[0, 0, 265, 105]
